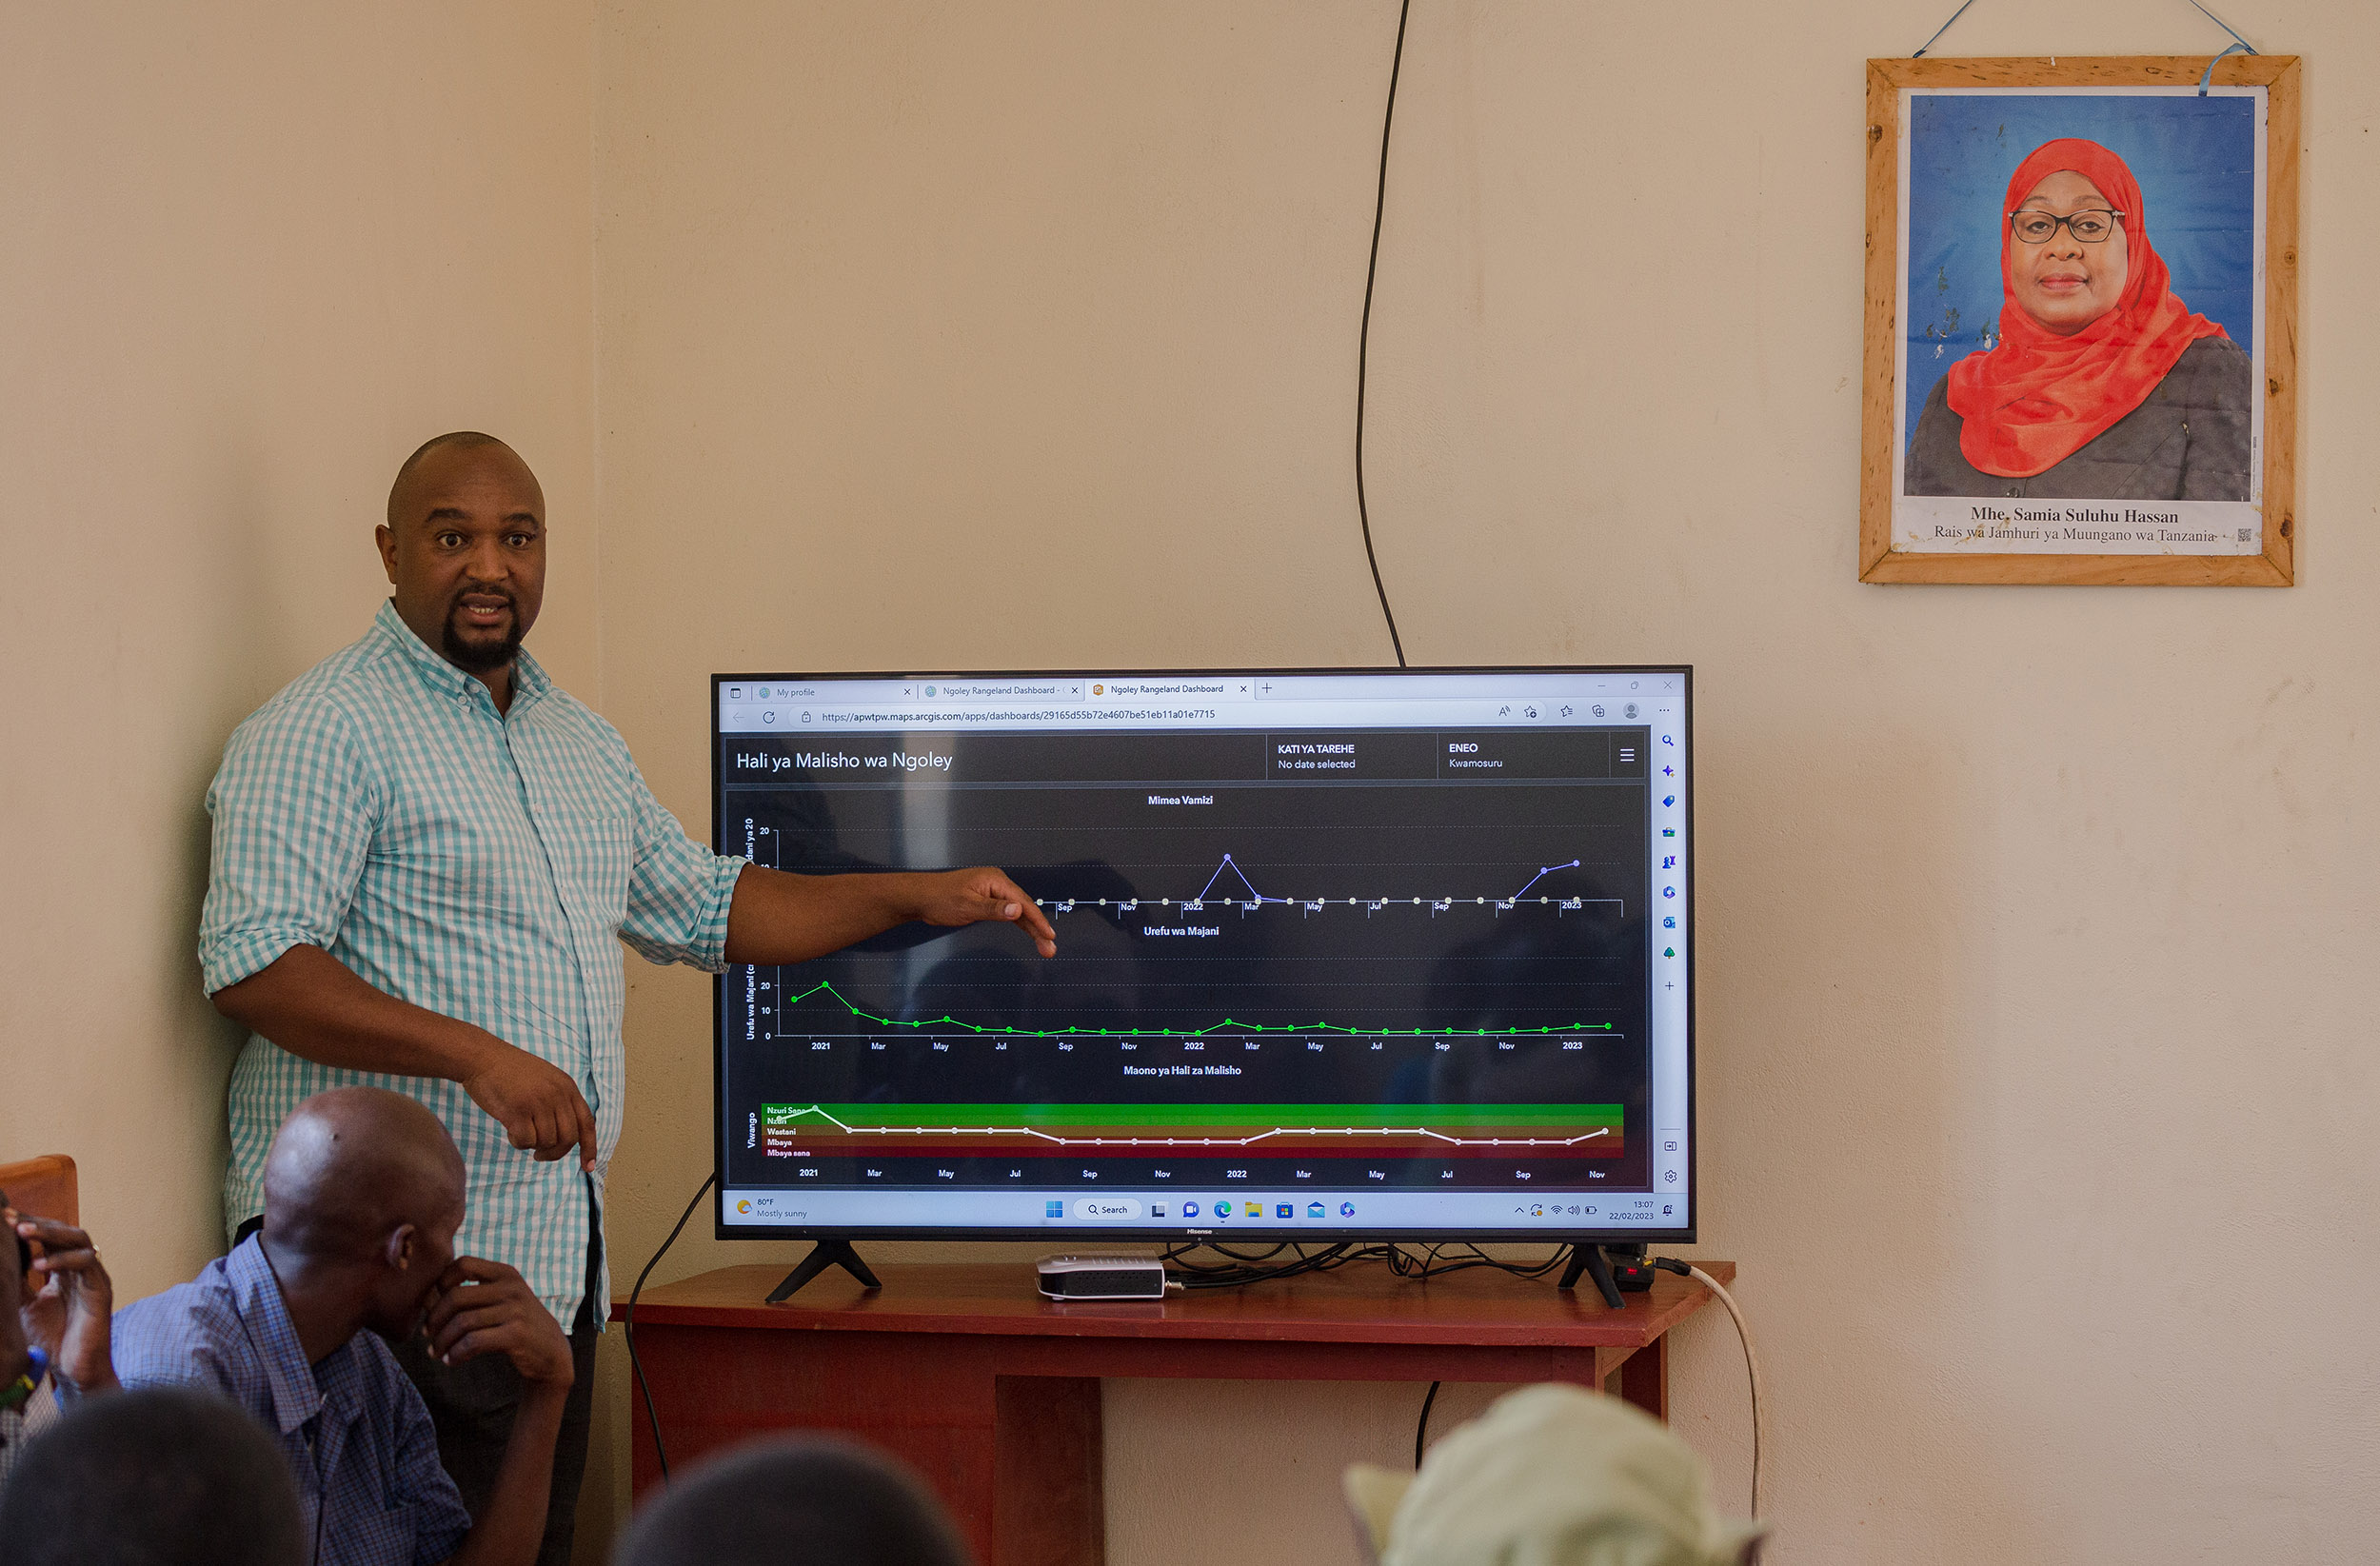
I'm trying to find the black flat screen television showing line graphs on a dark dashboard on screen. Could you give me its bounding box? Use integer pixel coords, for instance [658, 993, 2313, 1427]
[712, 666, 1695, 1247]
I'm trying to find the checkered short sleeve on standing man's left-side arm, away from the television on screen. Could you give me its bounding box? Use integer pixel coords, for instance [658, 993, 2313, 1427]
[198, 700, 379, 995]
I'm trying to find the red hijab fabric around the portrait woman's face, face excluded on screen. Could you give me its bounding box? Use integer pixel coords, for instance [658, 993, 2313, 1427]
[1950, 138, 2223, 479]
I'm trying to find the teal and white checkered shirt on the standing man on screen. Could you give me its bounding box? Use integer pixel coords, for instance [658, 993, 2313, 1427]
[198, 605, 745, 1326]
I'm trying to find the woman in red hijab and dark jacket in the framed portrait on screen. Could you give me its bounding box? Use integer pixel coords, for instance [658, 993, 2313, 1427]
[1904, 138, 2254, 500]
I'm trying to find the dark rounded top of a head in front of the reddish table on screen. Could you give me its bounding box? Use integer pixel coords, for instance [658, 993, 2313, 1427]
[614, 1437, 969, 1566]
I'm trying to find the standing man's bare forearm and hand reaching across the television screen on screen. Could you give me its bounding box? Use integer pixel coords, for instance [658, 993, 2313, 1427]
[726, 864, 1057, 964]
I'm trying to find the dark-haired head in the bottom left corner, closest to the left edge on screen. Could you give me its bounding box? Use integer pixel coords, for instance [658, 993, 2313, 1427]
[0, 1388, 312, 1566]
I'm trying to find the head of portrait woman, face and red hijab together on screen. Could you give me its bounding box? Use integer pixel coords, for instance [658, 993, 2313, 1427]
[1950, 136, 2226, 479]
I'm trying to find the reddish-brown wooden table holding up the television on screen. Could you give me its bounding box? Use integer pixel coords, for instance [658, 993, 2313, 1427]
[612, 1261, 1735, 1566]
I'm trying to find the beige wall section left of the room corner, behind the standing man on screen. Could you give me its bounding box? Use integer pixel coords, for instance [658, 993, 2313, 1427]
[0, 0, 595, 1323]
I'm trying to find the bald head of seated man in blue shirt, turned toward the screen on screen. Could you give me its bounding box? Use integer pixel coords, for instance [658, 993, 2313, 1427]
[265, 1088, 465, 1261]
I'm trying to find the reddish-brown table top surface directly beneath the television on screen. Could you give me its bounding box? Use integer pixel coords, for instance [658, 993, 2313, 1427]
[612, 1261, 1735, 1347]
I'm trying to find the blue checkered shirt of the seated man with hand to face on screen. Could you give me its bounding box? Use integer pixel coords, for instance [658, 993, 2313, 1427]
[109, 1240, 471, 1566]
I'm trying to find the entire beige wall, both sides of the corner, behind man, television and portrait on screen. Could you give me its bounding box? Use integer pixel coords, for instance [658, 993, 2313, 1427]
[0, 0, 2380, 1566]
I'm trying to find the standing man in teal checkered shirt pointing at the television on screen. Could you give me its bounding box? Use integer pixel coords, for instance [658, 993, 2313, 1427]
[200, 433, 1057, 1564]
